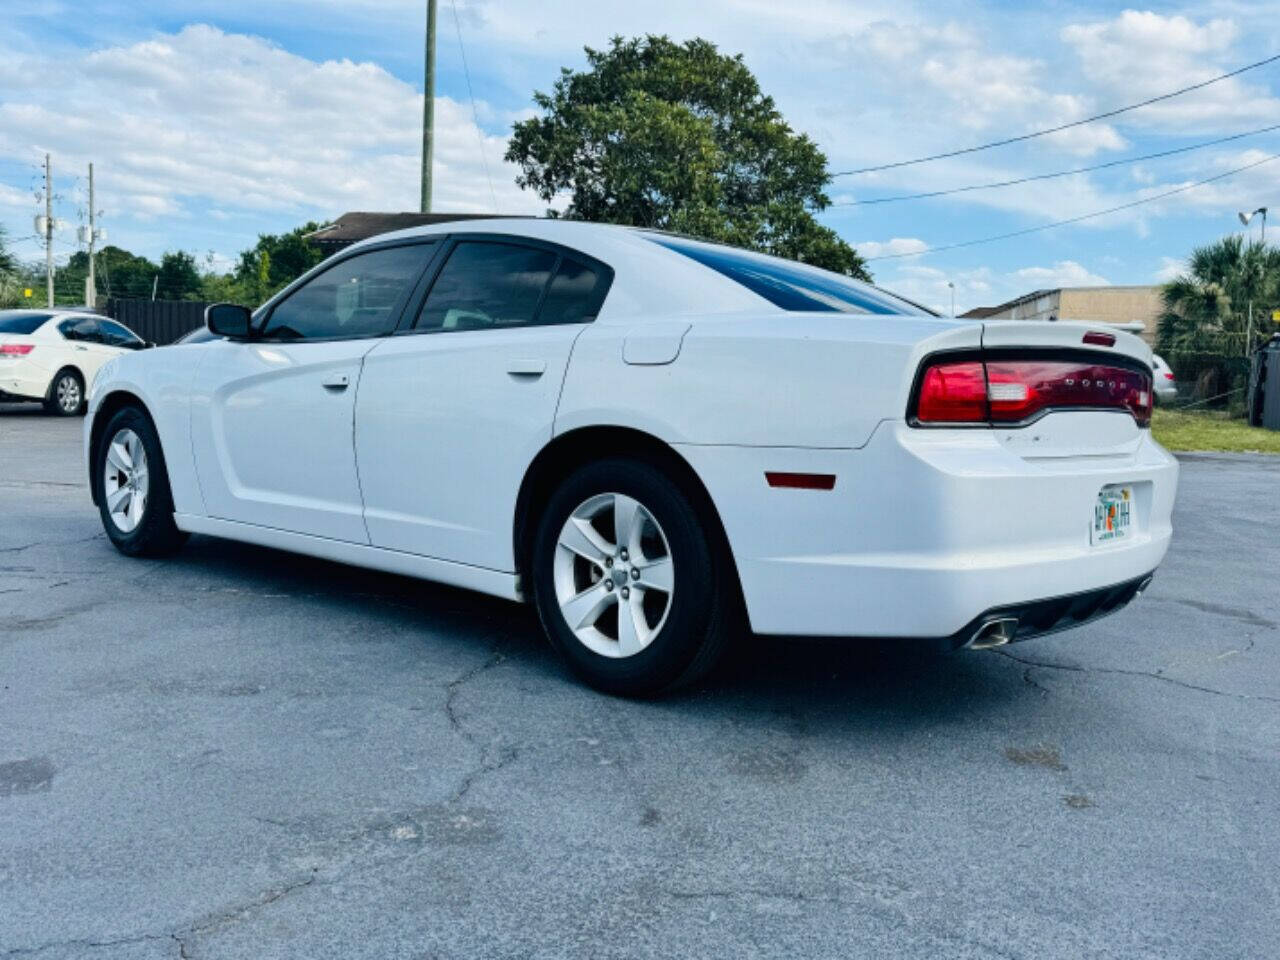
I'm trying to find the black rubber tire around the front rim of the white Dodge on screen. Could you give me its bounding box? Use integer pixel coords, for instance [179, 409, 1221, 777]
[92, 407, 187, 557]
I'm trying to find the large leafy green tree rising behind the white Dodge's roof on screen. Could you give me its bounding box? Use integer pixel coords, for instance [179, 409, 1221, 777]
[507, 36, 869, 279]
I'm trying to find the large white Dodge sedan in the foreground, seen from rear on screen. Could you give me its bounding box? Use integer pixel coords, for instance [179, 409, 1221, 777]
[84, 220, 1178, 694]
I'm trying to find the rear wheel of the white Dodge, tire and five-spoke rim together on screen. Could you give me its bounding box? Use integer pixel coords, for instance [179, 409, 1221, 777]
[532, 458, 733, 696]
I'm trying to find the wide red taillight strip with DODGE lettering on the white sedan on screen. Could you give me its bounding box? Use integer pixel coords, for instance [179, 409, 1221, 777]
[915, 360, 1151, 426]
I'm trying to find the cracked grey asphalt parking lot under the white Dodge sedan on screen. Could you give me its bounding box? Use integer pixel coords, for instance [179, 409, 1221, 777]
[0, 407, 1280, 960]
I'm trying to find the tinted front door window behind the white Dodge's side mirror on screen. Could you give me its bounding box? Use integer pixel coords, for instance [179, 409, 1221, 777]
[262, 243, 433, 340]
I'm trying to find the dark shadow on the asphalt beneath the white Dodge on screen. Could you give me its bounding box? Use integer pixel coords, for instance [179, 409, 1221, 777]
[152, 536, 1028, 727]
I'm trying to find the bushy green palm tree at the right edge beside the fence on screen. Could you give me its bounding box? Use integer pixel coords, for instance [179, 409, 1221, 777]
[1156, 236, 1280, 397]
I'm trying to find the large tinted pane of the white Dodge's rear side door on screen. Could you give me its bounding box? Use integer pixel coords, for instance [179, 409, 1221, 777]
[417, 241, 557, 330]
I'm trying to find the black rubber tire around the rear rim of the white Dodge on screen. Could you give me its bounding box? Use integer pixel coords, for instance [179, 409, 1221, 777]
[530, 457, 739, 696]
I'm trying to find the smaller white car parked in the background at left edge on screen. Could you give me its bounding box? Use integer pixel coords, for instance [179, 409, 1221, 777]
[0, 310, 147, 416]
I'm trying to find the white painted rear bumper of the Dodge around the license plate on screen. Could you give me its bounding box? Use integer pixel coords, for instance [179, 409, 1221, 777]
[678, 415, 1178, 639]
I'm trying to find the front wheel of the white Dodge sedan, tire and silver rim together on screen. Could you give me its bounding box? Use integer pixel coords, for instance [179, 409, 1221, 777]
[92, 407, 187, 557]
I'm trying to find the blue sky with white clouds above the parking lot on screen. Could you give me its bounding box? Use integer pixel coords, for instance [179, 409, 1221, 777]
[0, 0, 1280, 310]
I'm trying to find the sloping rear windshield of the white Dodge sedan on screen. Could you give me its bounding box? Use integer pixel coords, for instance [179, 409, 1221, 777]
[649, 234, 933, 316]
